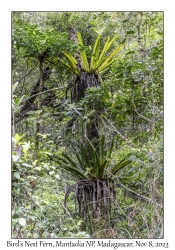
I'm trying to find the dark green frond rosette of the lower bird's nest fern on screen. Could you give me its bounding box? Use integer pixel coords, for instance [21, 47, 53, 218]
[49, 136, 132, 179]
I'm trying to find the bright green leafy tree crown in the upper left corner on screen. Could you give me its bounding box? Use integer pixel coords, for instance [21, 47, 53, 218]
[12, 23, 77, 58]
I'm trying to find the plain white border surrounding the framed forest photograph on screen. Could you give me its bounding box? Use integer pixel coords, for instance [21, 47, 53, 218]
[0, 0, 175, 249]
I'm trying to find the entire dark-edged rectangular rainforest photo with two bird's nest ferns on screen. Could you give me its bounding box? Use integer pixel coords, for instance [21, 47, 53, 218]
[12, 12, 164, 238]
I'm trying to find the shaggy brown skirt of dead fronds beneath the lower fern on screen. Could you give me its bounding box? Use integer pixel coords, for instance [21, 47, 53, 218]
[76, 179, 115, 238]
